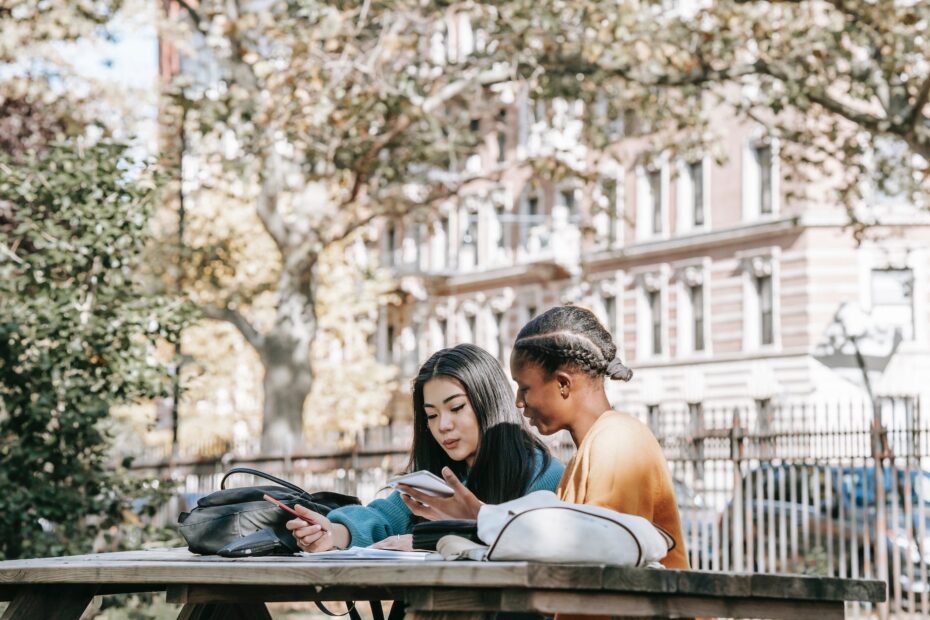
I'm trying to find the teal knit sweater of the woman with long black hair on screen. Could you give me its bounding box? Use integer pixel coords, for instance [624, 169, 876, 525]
[326, 452, 565, 547]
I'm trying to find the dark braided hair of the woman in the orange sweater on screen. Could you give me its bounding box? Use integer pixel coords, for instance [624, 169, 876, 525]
[513, 306, 633, 381]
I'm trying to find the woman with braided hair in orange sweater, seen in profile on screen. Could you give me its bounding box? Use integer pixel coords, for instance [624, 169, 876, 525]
[400, 306, 689, 568]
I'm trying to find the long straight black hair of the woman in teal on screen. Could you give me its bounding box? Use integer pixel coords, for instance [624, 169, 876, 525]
[410, 344, 552, 504]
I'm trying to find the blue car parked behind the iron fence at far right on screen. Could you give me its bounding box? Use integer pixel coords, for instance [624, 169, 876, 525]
[723, 464, 930, 597]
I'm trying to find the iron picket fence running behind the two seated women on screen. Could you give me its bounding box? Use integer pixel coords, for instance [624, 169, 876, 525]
[138, 397, 930, 617]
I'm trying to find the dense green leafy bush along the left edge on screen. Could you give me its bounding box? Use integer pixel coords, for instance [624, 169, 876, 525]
[0, 142, 185, 559]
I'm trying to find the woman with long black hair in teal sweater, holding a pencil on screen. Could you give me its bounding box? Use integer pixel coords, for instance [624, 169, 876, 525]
[287, 344, 564, 551]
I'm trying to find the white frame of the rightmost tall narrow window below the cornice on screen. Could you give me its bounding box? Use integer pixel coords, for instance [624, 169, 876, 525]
[736, 247, 781, 352]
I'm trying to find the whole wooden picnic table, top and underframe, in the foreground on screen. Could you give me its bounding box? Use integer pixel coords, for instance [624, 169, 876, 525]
[0, 549, 885, 620]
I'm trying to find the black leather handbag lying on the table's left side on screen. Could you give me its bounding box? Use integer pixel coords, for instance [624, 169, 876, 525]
[178, 467, 359, 557]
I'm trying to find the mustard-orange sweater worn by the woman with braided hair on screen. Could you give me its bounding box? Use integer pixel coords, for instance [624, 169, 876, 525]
[558, 411, 689, 568]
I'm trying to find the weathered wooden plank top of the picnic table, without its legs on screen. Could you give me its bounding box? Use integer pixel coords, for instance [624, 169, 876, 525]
[0, 549, 885, 602]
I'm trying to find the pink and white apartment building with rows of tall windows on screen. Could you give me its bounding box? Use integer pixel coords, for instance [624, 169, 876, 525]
[377, 95, 930, 422]
